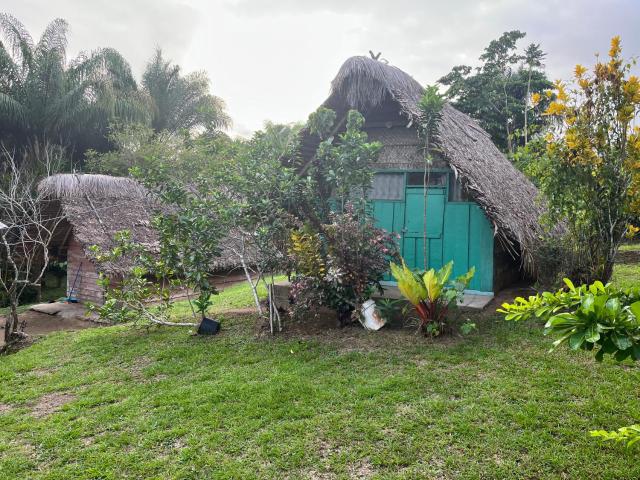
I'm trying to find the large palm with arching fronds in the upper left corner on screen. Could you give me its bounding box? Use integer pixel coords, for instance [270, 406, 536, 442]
[0, 13, 150, 161]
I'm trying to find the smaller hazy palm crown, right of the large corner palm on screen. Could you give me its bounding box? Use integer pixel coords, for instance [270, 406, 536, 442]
[142, 48, 231, 132]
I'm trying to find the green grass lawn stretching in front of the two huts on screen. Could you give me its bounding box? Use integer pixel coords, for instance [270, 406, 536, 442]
[0, 270, 640, 479]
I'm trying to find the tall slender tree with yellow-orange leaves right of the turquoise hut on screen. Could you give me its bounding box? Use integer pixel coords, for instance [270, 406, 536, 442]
[539, 37, 640, 282]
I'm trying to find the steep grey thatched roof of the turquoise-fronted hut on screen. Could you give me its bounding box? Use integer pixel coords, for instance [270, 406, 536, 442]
[303, 57, 543, 270]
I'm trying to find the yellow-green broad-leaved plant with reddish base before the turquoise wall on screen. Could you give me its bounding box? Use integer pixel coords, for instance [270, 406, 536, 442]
[391, 260, 475, 336]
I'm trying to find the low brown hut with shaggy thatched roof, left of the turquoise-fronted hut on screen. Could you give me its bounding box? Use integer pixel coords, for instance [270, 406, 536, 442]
[39, 174, 239, 304]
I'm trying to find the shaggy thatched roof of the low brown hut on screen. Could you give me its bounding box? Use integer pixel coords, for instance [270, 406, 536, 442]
[38, 174, 245, 274]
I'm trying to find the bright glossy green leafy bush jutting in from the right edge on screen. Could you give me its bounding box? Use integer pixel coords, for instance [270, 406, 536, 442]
[498, 278, 640, 361]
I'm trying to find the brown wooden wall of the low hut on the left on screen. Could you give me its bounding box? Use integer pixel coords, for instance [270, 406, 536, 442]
[67, 235, 104, 305]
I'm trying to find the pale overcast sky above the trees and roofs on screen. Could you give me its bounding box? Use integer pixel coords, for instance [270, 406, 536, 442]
[5, 0, 640, 135]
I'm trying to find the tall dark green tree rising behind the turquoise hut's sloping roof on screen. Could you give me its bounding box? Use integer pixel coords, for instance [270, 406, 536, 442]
[438, 30, 552, 153]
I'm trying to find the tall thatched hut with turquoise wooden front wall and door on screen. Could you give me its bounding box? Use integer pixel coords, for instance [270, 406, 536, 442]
[302, 57, 542, 293]
